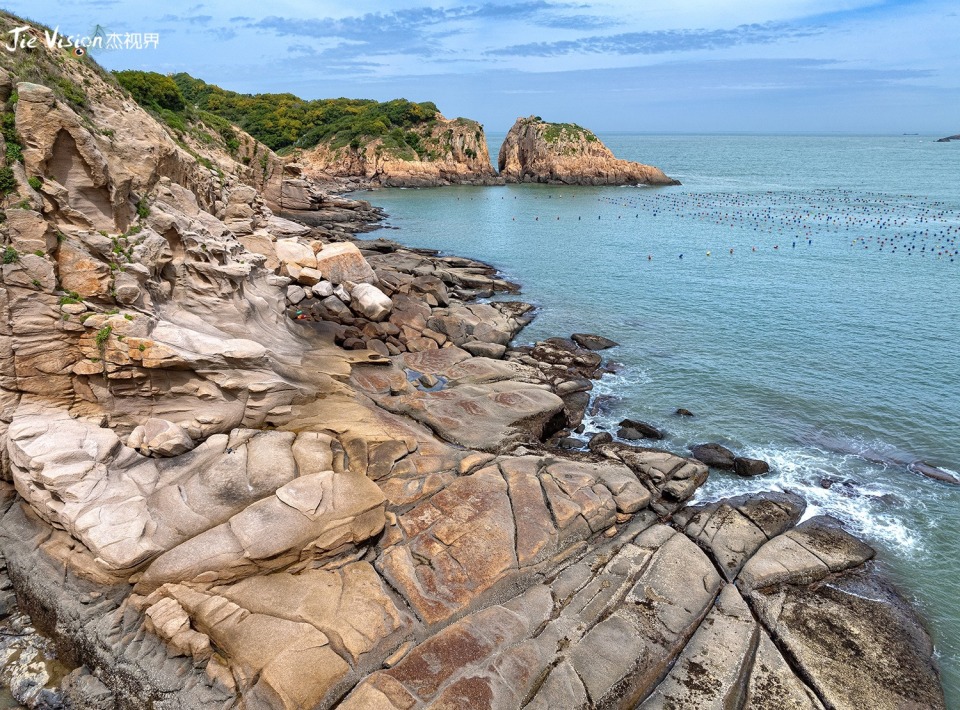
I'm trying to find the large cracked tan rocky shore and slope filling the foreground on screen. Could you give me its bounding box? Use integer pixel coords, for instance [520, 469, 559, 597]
[0, 15, 944, 710]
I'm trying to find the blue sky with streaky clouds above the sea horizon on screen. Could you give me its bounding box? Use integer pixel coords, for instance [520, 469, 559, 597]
[2, 0, 960, 135]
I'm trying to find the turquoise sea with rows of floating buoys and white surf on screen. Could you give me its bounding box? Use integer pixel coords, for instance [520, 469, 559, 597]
[356, 135, 960, 707]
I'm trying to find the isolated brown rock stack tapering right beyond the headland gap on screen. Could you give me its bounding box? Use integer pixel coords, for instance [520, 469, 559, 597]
[498, 116, 680, 185]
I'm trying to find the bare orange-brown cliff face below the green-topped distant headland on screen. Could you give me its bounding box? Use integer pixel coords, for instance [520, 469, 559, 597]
[300, 114, 501, 187]
